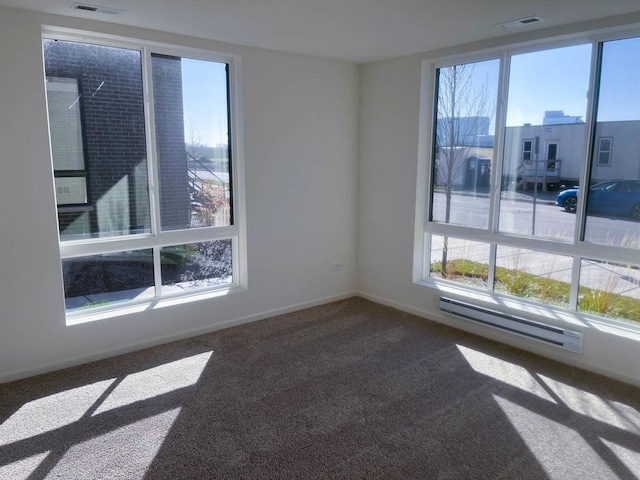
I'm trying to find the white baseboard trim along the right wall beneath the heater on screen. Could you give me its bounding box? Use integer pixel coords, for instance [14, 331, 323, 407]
[357, 291, 640, 387]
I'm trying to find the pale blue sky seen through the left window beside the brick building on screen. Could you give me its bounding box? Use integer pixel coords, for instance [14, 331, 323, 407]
[182, 58, 228, 146]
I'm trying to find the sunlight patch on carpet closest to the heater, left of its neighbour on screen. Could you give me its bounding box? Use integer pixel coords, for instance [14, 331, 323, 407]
[456, 345, 556, 403]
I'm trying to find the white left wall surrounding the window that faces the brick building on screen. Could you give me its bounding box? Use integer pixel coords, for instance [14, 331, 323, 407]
[0, 8, 359, 381]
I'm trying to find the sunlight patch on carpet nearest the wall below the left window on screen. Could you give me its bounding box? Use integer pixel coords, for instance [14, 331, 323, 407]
[93, 351, 213, 416]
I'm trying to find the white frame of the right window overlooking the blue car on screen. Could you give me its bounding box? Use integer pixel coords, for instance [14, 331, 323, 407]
[413, 29, 640, 336]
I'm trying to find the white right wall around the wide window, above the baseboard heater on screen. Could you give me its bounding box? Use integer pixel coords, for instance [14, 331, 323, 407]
[358, 21, 640, 385]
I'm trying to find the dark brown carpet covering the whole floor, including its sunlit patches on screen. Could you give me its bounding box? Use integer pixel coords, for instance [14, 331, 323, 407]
[0, 298, 640, 480]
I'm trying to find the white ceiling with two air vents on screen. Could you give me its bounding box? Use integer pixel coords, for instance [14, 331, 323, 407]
[0, 0, 640, 62]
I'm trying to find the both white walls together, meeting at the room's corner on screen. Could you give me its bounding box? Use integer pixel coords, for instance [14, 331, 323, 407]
[0, 8, 640, 384]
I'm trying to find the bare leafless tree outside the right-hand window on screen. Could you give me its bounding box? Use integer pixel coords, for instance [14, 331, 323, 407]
[434, 64, 493, 275]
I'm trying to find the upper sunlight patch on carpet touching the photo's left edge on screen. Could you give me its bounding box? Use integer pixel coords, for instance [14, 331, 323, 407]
[0, 379, 115, 446]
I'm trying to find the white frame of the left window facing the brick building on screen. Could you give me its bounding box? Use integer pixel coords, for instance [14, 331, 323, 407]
[42, 26, 248, 325]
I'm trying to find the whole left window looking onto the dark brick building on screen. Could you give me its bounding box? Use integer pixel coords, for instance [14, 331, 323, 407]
[43, 34, 244, 315]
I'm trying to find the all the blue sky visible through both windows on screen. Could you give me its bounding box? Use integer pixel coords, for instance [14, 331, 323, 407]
[182, 38, 640, 146]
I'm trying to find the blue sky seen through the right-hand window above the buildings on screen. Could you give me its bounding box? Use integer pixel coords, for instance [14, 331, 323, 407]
[448, 38, 640, 133]
